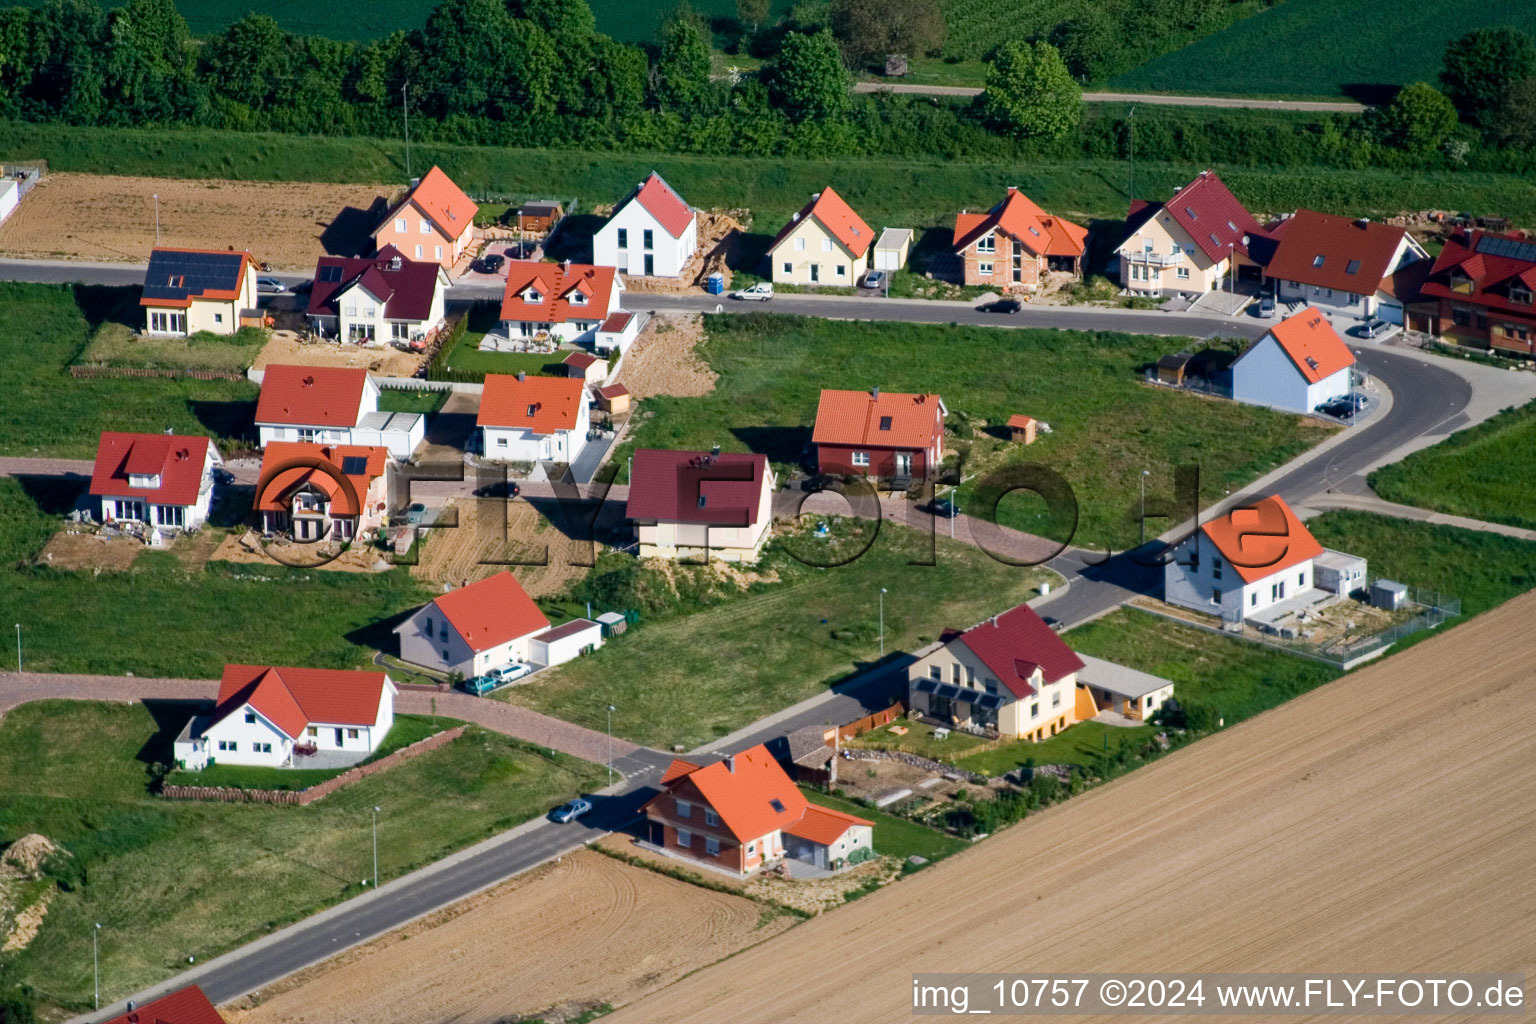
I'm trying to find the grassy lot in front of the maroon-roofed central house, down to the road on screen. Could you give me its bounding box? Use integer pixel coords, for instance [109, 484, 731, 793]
[502, 522, 1057, 749]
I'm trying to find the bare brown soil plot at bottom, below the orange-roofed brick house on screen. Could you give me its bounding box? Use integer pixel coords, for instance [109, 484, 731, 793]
[224, 851, 793, 1024]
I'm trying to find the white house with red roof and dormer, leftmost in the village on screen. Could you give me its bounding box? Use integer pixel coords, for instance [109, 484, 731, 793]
[91, 431, 224, 530]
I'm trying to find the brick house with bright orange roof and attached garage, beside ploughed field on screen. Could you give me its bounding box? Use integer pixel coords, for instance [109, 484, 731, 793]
[642, 743, 874, 875]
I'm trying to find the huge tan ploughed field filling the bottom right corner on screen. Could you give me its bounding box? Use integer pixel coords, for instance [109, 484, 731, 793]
[604, 594, 1536, 1024]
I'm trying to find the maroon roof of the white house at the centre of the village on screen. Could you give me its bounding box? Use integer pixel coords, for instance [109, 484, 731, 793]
[625, 448, 768, 527]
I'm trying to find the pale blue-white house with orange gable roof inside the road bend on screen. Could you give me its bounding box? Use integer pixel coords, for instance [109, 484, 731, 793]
[1232, 306, 1355, 413]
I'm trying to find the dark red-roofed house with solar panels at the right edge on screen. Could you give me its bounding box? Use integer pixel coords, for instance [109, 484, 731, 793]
[1421, 230, 1536, 356]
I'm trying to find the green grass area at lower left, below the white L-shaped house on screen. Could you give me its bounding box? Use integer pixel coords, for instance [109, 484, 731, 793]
[0, 702, 601, 1016]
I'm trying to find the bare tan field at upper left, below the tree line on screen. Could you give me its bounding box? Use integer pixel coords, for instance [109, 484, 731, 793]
[0, 172, 393, 270]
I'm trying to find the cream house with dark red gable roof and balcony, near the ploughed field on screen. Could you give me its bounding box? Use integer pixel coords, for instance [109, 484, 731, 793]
[906, 605, 1083, 740]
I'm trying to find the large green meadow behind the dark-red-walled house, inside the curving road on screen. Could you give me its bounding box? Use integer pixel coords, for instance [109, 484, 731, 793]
[614, 313, 1330, 548]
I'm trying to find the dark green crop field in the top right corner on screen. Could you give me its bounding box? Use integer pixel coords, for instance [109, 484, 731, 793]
[1111, 0, 1536, 100]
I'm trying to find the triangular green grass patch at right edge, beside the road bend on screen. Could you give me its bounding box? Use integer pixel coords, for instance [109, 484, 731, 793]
[1370, 402, 1536, 530]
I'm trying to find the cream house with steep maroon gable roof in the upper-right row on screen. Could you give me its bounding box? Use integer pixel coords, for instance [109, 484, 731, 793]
[1115, 170, 1270, 296]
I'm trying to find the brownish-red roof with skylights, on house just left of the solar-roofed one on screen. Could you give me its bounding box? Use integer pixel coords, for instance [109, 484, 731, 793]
[1266, 210, 1407, 295]
